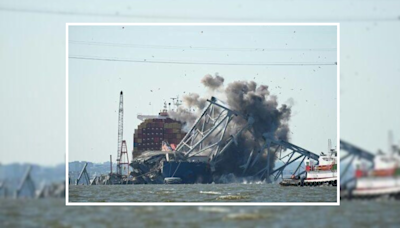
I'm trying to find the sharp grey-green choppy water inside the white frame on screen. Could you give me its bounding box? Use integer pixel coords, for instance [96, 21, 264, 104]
[69, 183, 337, 202]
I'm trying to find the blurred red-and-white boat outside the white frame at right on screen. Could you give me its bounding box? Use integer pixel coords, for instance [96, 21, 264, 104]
[348, 153, 400, 199]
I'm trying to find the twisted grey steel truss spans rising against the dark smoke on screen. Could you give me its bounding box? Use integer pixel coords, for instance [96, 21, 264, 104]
[174, 97, 319, 181]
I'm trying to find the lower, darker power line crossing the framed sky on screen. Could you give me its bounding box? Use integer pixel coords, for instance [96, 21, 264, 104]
[69, 56, 337, 66]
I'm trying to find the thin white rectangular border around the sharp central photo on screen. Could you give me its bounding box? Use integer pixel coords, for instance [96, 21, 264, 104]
[65, 23, 340, 206]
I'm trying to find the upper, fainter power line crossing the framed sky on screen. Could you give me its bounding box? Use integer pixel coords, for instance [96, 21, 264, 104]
[69, 40, 336, 52]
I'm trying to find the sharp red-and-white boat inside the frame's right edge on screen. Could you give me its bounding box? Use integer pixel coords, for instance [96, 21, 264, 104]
[280, 149, 337, 186]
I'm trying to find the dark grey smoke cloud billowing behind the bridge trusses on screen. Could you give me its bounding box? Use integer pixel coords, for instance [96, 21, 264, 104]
[169, 74, 291, 181]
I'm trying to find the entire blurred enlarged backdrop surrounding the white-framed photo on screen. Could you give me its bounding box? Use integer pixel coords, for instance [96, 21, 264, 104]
[0, 0, 400, 227]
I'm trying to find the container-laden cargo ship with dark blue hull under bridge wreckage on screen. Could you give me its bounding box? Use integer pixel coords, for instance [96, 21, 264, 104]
[131, 105, 212, 184]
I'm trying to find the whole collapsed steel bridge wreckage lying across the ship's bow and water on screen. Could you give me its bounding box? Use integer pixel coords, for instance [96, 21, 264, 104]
[131, 97, 319, 183]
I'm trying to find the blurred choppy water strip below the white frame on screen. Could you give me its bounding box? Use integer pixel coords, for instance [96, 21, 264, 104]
[0, 199, 400, 228]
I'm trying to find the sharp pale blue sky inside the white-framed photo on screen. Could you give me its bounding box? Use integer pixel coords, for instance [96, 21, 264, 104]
[68, 26, 337, 162]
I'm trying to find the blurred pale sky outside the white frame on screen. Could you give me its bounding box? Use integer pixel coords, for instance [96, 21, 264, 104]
[0, 0, 400, 165]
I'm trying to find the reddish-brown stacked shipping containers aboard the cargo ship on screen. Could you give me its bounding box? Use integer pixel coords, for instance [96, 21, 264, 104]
[133, 118, 185, 157]
